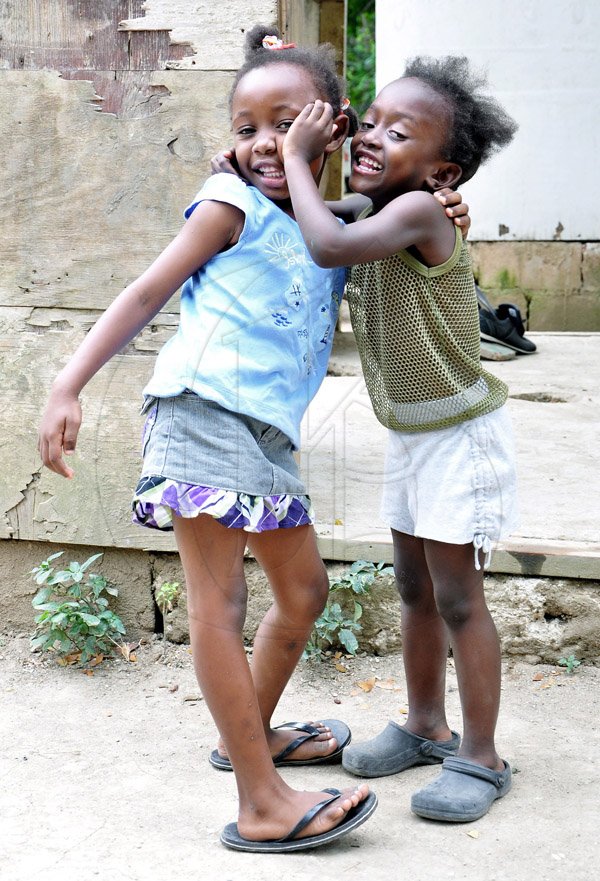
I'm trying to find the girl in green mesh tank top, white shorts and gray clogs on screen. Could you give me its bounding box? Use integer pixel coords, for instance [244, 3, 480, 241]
[283, 58, 516, 822]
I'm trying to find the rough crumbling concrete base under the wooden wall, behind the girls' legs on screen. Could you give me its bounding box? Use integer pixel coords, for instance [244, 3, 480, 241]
[0, 541, 600, 663]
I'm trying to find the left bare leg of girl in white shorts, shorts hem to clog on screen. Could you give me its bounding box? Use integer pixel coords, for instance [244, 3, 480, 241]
[392, 529, 452, 741]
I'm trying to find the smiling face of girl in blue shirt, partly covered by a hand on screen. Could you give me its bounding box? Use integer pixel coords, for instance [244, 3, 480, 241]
[231, 64, 324, 214]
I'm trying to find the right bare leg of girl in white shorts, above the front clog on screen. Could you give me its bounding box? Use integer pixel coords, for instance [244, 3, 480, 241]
[424, 539, 504, 771]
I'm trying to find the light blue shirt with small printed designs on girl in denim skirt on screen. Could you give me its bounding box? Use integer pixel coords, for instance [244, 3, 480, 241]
[144, 174, 345, 448]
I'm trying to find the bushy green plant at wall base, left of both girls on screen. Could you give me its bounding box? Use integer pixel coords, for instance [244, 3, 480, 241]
[30, 551, 125, 665]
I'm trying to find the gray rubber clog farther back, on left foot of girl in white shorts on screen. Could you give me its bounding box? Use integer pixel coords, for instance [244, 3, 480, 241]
[342, 722, 460, 777]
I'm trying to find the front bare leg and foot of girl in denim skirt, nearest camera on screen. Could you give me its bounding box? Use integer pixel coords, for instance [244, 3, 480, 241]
[174, 515, 368, 840]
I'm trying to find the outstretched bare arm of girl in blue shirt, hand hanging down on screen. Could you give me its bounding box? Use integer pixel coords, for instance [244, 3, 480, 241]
[38, 201, 244, 477]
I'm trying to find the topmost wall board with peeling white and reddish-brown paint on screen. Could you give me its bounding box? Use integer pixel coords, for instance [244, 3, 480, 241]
[0, 0, 278, 71]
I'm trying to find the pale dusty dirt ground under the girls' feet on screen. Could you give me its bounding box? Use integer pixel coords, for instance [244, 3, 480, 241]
[0, 636, 600, 881]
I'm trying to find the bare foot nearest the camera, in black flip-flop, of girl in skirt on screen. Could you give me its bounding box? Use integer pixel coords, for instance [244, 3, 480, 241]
[237, 783, 369, 841]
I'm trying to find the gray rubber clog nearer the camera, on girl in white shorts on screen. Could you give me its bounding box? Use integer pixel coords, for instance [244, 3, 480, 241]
[410, 756, 512, 823]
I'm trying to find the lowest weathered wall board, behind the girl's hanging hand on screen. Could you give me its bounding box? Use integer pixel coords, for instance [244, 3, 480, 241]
[0, 307, 177, 550]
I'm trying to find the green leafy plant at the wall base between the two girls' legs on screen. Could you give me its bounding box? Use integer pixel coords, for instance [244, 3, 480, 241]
[302, 560, 394, 659]
